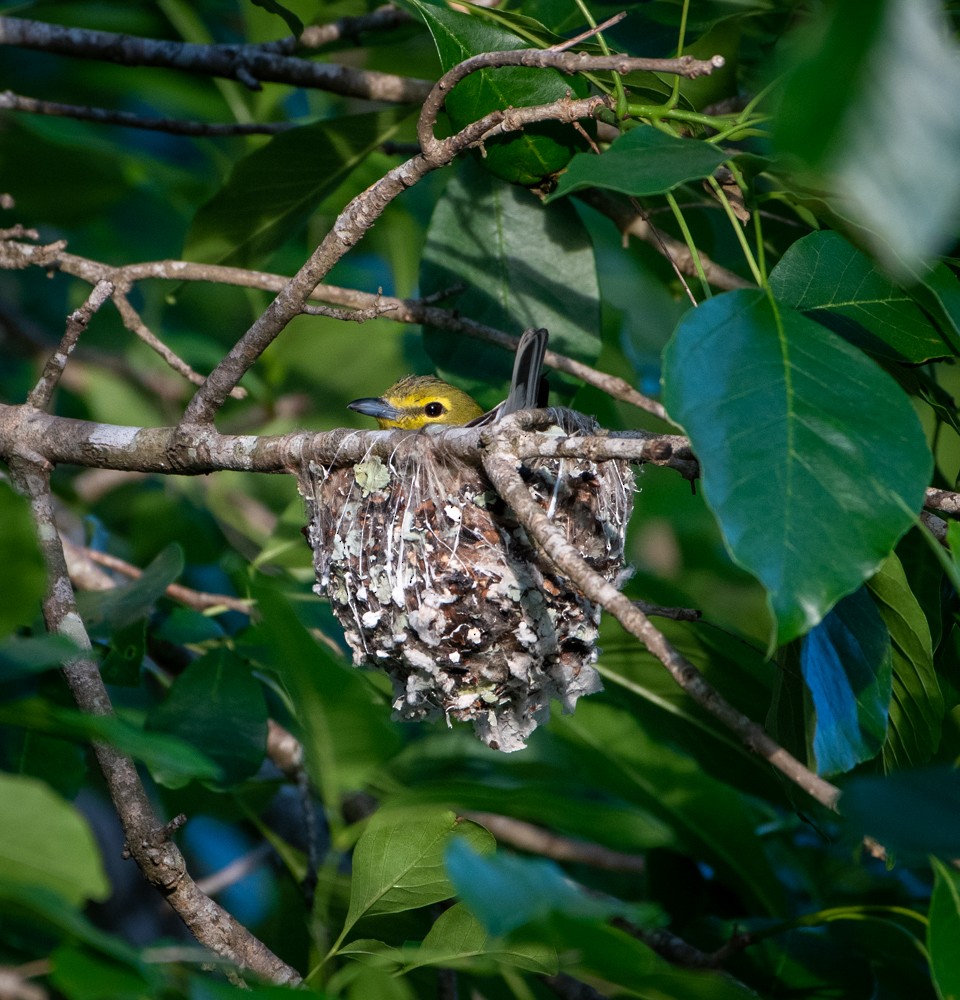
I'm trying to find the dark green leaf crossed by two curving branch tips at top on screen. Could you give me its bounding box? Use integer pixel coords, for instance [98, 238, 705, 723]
[405, 0, 584, 185]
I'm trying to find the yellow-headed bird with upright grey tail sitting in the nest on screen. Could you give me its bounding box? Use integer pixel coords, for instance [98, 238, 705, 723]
[347, 329, 548, 430]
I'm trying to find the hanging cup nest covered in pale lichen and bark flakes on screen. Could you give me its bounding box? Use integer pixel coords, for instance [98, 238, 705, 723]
[300, 410, 634, 751]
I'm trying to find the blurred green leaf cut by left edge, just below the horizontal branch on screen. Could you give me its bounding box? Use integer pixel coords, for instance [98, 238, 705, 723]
[0, 481, 46, 638]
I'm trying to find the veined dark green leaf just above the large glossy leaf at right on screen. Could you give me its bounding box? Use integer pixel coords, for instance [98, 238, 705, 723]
[770, 232, 955, 364]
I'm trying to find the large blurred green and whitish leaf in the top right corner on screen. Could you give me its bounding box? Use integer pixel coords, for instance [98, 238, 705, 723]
[777, 0, 960, 275]
